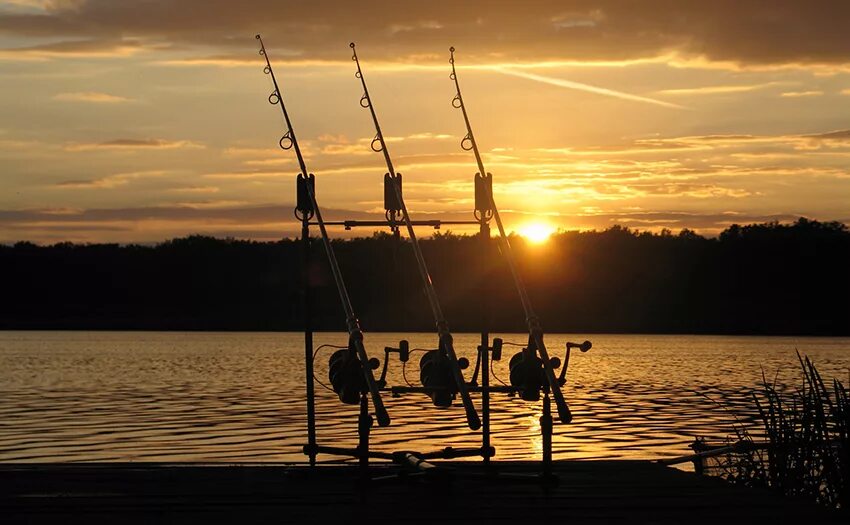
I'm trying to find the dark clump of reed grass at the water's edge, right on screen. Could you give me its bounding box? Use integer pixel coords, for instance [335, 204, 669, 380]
[712, 352, 850, 509]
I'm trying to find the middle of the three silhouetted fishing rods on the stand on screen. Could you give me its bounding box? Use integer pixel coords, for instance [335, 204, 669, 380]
[350, 42, 481, 430]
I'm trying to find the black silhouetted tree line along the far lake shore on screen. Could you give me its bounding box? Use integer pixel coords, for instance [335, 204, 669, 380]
[0, 218, 850, 335]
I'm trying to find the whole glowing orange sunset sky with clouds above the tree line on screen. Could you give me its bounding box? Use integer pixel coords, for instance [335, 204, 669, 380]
[0, 0, 850, 242]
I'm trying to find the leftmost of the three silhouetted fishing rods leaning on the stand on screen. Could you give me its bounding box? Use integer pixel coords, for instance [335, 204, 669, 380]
[256, 35, 390, 427]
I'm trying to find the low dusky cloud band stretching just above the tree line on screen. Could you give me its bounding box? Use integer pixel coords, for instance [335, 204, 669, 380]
[0, 201, 832, 242]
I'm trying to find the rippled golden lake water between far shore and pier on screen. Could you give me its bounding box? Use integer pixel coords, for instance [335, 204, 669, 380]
[0, 332, 850, 462]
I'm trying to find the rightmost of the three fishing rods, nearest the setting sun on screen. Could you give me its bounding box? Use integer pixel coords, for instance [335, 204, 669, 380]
[449, 47, 572, 423]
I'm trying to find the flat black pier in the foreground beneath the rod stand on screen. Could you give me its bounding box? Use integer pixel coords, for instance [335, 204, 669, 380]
[0, 461, 847, 524]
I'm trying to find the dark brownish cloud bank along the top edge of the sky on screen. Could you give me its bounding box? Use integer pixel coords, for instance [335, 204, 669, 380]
[0, 0, 850, 67]
